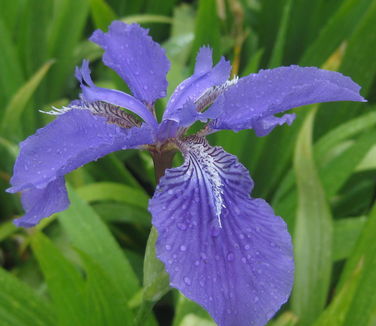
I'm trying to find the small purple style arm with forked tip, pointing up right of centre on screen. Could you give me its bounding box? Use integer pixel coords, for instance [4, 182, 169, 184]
[163, 47, 231, 120]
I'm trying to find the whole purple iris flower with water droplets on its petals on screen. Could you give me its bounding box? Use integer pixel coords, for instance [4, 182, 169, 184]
[8, 21, 364, 326]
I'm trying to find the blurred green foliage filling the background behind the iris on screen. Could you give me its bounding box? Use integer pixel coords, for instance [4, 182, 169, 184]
[0, 0, 376, 326]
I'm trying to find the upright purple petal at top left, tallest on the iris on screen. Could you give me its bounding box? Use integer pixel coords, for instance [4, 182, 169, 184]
[90, 21, 170, 104]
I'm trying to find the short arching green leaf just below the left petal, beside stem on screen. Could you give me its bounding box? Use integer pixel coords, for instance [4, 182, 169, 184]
[77, 182, 149, 208]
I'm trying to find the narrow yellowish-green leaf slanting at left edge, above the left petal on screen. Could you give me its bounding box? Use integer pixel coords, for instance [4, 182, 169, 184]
[0, 60, 53, 136]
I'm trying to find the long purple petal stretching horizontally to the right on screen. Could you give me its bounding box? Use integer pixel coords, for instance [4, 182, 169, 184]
[208, 66, 365, 135]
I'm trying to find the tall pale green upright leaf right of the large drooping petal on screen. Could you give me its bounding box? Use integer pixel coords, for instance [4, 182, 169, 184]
[292, 110, 332, 325]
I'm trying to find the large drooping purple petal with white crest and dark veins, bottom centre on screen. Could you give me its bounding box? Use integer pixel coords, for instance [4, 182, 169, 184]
[149, 138, 294, 326]
